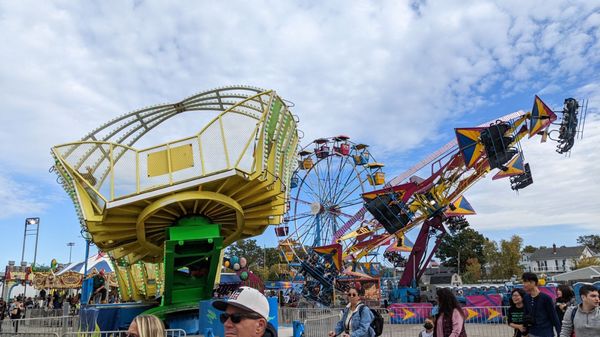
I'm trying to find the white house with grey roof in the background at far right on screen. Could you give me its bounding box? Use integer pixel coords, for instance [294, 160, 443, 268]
[521, 244, 595, 274]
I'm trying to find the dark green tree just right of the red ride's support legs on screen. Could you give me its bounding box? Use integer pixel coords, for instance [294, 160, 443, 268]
[435, 227, 487, 270]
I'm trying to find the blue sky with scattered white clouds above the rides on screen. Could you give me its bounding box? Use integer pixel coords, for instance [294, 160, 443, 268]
[0, 0, 600, 265]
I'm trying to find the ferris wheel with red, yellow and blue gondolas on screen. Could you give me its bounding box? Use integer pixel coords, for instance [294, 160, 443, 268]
[275, 135, 385, 265]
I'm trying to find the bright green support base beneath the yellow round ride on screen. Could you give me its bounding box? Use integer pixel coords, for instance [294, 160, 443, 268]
[144, 216, 223, 319]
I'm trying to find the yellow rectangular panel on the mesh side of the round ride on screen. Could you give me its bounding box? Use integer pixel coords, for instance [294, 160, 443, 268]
[148, 144, 194, 177]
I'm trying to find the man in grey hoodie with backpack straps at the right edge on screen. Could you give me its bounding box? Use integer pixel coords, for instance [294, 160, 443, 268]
[560, 284, 600, 337]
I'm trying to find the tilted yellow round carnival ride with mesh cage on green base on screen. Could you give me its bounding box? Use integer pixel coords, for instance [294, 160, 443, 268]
[52, 86, 298, 319]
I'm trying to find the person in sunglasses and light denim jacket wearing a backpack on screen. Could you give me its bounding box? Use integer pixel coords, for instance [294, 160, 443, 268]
[329, 288, 375, 337]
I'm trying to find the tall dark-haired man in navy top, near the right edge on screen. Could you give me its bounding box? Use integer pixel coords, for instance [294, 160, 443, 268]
[521, 272, 561, 337]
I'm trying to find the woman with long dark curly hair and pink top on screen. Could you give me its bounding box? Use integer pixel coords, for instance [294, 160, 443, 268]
[433, 288, 467, 337]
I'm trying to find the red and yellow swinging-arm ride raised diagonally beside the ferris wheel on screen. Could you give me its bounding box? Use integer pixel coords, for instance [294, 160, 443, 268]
[290, 96, 587, 304]
